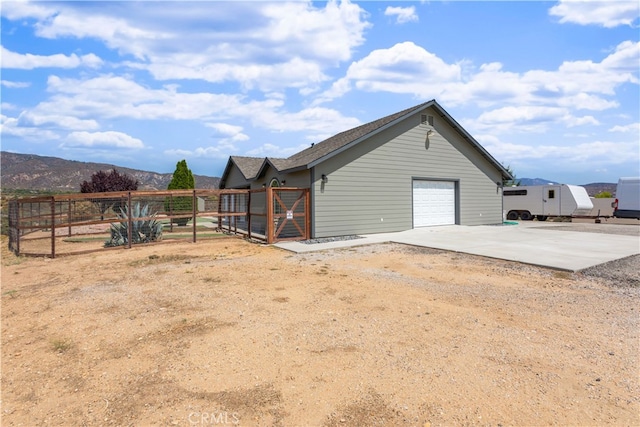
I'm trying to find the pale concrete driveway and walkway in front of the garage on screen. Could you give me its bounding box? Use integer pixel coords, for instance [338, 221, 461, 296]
[275, 221, 640, 271]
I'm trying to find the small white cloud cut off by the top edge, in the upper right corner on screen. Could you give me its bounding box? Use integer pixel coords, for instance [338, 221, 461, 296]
[549, 0, 640, 28]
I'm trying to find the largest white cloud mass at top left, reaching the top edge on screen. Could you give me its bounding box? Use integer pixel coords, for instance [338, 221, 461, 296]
[6, 0, 370, 91]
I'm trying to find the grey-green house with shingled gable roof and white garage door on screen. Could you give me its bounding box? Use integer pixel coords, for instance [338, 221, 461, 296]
[220, 100, 512, 241]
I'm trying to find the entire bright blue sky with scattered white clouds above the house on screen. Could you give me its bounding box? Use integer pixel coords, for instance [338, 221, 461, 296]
[0, 0, 640, 184]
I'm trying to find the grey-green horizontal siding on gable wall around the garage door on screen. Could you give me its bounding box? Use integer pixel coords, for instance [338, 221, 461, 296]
[312, 110, 502, 237]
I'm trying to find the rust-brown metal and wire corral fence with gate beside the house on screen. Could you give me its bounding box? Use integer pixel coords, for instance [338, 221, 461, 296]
[8, 187, 310, 258]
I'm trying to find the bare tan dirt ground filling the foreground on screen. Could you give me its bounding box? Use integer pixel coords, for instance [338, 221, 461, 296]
[1, 238, 640, 426]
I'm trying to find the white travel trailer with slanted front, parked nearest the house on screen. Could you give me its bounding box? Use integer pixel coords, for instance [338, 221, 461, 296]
[502, 184, 593, 221]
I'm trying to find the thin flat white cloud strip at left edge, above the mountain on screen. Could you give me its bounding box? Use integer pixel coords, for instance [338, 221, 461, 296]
[1, 46, 102, 70]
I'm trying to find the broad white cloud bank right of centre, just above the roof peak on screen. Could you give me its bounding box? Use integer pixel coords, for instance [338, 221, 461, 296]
[313, 41, 640, 136]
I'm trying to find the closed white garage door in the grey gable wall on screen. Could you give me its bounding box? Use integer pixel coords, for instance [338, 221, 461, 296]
[413, 180, 456, 228]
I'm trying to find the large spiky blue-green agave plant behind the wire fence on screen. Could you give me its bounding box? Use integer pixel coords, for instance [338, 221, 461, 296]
[104, 203, 162, 247]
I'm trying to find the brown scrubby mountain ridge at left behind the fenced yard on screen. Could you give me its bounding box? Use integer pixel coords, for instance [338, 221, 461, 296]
[0, 151, 220, 192]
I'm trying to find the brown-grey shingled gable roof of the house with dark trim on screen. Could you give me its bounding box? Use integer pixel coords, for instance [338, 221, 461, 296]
[221, 99, 513, 184]
